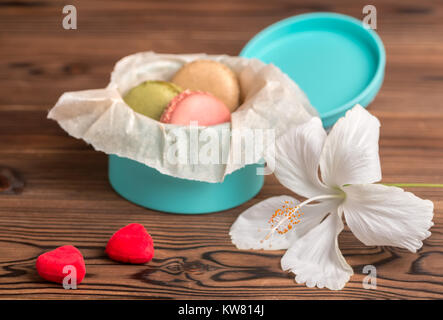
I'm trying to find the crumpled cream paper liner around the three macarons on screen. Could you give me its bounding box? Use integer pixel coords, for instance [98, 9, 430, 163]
[48, 52, 317, 182]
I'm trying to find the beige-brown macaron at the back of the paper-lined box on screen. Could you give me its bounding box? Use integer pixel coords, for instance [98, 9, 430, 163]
[172, 60, 240, 112]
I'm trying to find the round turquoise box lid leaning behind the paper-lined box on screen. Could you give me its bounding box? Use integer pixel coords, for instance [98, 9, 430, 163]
[240, 13, 386, 127]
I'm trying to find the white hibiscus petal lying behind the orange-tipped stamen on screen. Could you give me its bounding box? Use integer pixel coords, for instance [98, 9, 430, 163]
[229, 196, 338, 250]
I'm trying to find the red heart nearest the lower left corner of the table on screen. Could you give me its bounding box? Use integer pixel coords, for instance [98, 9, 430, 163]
[35, 246, 86, 284]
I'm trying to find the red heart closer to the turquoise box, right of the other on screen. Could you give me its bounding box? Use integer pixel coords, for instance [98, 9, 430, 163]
[106, 223, 154, 264]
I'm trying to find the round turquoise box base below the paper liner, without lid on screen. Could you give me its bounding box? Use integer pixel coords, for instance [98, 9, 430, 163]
[109, 155, 264, 214]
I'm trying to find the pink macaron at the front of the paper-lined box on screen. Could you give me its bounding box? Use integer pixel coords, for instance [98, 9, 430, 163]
[160, 90, 231, 126]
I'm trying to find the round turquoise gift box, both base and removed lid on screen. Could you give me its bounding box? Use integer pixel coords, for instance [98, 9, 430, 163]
[109, 13, 386, 214]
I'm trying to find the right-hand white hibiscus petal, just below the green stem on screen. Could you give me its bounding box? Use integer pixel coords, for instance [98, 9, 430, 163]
[342, 184, 434, 252]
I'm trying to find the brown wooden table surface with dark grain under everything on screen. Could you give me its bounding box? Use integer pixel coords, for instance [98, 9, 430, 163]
[0, 0, 443, 299]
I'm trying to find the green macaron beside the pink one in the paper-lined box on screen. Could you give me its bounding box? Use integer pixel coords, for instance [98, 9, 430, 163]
[123, 81, 182, 120]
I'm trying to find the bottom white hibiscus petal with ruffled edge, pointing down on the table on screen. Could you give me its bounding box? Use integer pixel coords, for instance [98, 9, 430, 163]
[281, 212, 353, 290]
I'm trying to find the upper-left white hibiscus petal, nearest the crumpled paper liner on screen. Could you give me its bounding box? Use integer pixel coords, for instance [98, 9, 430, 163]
[274, 117, 330, 198]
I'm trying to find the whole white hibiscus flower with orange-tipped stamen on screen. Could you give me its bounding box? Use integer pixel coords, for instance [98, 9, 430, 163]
[230, 105, 434, 290]
